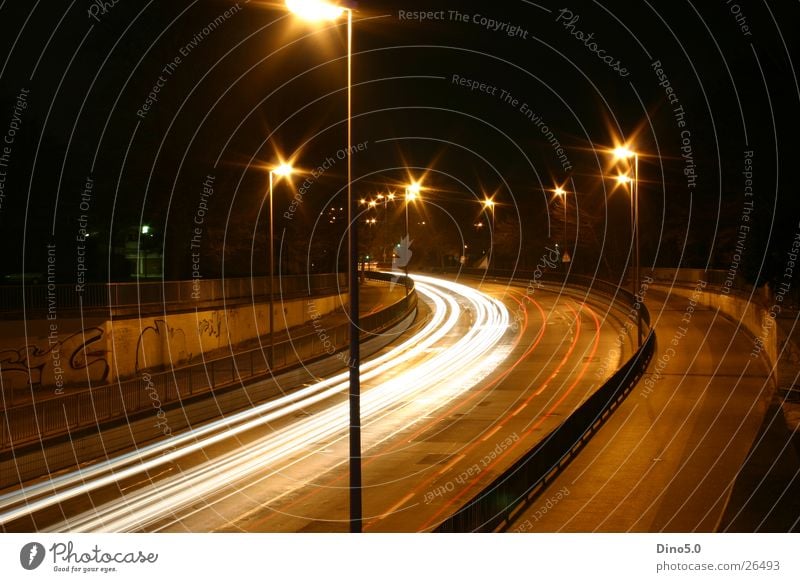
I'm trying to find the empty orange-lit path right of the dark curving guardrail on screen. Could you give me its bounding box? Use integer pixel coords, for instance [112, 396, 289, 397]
[508, 290, 798, 532]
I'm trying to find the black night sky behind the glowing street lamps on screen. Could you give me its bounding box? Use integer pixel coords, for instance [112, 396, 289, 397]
[0, 0, 800, 281]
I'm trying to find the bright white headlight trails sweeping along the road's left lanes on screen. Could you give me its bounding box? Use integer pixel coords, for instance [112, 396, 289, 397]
[0, 277, 509, 531]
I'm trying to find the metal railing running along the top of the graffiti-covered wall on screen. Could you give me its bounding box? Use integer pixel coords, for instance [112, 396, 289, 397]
[0, 273, 347, 312]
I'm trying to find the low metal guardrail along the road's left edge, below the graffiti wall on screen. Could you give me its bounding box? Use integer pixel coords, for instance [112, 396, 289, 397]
[0, 273, 417, 452]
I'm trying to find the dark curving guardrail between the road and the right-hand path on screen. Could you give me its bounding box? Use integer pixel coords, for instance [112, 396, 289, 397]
[435, 277, 656, 533]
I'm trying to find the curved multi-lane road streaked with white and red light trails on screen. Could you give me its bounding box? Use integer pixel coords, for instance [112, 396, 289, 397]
[0, 276, 630, 532]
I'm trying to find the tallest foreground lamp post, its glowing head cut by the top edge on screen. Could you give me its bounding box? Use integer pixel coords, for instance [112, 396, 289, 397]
[286, 0, 362, 533]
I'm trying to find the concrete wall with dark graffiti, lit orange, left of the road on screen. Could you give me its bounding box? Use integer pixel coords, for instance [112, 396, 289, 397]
[0, 294, 347, 393]
